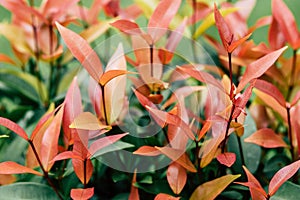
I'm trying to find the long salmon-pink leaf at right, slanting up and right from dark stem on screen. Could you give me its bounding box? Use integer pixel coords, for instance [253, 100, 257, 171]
[237, 46, 287, 93]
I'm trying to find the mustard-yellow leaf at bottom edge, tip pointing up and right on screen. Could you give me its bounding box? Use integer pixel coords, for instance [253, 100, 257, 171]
[190, 174, 241, 200]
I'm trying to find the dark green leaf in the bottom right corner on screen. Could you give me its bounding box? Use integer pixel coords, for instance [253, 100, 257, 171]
[271, 181, 300, 200]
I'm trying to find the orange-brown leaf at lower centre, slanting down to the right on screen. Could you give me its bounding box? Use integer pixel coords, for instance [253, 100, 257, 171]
[155, 147, 197, 172]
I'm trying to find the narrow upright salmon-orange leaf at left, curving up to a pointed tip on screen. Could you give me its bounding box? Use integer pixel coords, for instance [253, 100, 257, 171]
[40, 107, 64, 171]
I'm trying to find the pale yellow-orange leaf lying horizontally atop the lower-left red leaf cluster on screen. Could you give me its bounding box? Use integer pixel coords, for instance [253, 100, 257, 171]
[70, 112, 110, 131]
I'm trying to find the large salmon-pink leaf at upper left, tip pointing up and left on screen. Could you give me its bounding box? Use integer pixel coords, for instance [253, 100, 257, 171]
[55, 22, 103, 82]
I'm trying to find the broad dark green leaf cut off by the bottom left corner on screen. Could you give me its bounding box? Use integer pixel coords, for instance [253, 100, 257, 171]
[0, 182, 58, 200]
